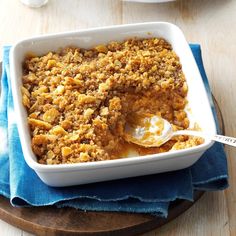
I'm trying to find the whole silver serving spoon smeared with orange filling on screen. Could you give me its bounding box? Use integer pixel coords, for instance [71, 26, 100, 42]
[124, 114, 236, 147]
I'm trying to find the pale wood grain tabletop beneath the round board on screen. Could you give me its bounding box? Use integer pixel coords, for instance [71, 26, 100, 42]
[0, 0, 236, 236]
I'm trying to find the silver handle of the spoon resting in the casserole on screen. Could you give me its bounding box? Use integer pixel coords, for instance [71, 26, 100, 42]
[173, 130, 236, 147]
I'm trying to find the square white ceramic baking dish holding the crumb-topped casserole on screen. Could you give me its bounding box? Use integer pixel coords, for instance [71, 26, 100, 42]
[10, 22, 216, 186]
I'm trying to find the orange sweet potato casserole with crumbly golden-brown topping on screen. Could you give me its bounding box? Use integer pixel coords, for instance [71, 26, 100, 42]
[22, 38, 203, 164]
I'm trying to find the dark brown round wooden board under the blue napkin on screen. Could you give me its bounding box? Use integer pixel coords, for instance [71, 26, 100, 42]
[0, 63, 224, 236]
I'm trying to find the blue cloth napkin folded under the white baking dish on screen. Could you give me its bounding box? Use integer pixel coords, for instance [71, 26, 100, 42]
[0, 45, 228, 217]
